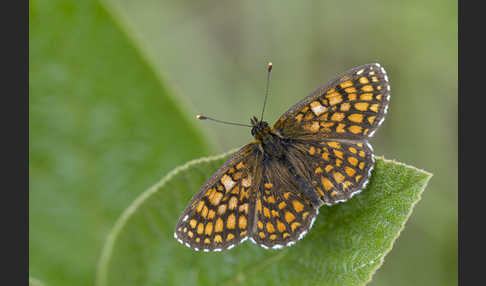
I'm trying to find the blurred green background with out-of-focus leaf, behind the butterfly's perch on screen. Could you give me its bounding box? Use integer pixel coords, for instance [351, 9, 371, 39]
[29, 0, 457, 285]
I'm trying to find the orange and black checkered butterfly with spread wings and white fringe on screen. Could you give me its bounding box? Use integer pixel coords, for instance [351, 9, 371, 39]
[174, 63, 390, 251]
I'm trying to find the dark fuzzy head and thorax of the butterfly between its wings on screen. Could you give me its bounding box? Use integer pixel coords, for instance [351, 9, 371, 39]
[251, 117, 285, 161]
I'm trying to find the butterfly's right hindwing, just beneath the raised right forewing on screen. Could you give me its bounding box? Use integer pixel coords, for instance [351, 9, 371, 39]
[287, 140, 374, 205]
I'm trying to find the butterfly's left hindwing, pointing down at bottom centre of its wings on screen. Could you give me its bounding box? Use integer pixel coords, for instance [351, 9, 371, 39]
[252, 159, 318, 249]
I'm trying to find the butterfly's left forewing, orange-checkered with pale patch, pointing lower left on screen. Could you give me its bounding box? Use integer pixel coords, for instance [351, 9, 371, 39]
[174, 143, 261, 251]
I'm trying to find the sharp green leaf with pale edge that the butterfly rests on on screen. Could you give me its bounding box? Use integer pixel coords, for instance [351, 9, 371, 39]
[97, 152, 431, 286]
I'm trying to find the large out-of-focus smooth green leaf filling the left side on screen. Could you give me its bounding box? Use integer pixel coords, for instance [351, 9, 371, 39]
[29, 0, 212, 285]
